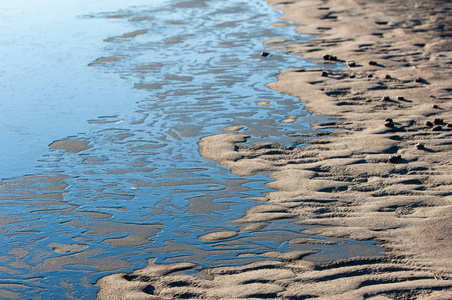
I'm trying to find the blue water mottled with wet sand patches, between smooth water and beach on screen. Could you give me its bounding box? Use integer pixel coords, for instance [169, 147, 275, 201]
[0, 0, 381, 299]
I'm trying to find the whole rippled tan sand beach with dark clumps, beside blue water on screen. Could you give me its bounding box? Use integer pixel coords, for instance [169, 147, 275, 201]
[98, 0, 452, 299]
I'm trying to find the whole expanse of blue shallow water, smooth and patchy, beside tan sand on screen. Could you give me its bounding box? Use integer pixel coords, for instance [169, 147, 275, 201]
[0, 0, 381, 299]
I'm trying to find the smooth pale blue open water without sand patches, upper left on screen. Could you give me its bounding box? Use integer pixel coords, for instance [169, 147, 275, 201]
[0, 0, 152, 178]
